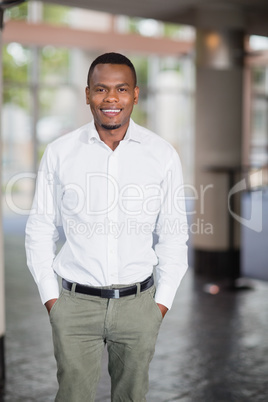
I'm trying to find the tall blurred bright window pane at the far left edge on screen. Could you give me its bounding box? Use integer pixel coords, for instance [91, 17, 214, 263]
[2, 87, 34, 215]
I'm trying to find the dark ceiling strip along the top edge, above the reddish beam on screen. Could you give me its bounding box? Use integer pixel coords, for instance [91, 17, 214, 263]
[38, 0, 268, 36]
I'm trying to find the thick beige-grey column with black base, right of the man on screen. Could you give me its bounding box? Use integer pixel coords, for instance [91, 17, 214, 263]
[194, 18, 244, 277]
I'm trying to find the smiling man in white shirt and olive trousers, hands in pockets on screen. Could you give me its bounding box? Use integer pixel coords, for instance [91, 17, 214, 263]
[26, 53, 187, 402]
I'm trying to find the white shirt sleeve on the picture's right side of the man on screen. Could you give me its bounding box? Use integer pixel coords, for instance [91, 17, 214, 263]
[155, 151, 188, 309]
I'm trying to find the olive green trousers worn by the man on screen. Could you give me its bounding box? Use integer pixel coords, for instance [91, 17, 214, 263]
[50, 286, 162, 402]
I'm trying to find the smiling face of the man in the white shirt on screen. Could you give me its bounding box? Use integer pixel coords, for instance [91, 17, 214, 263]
[86, 64, 139, 131]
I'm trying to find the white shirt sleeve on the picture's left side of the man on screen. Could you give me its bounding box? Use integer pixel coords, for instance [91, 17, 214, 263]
[25, 147, 59, 304]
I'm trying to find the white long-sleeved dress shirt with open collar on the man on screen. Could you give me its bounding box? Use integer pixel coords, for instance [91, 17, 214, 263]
[26, 120, 188, 308]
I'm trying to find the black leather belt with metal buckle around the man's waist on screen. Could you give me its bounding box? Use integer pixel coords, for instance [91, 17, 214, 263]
[62, 275, 154, 299]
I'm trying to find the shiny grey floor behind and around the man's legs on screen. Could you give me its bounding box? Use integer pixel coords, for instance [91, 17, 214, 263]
[0, 234, 268, 402]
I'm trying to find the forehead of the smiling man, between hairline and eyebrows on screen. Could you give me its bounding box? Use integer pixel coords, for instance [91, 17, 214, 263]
[90, 64, 134, 86]
